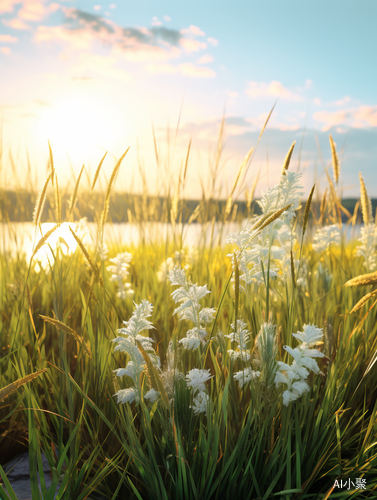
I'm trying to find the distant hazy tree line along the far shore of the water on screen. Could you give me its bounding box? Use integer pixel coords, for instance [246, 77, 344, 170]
[0, 190, 370, 223]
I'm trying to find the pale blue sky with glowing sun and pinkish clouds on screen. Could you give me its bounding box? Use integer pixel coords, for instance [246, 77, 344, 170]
[0, 0, 377, 199]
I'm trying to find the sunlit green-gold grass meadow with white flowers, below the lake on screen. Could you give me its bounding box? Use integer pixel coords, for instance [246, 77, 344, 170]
[0, 120, 377, 500]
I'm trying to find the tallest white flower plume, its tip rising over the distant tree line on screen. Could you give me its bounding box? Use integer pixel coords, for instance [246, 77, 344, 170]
[227, 172, 303, 290]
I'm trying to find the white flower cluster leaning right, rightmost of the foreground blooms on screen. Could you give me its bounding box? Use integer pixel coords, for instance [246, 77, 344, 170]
[275, 325, 324, 406]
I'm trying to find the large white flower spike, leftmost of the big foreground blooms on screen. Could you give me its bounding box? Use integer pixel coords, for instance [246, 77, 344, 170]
[111, 300, 161, 404]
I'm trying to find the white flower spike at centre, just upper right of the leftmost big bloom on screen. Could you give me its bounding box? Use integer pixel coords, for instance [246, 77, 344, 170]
[169, 266, 216, 349]
